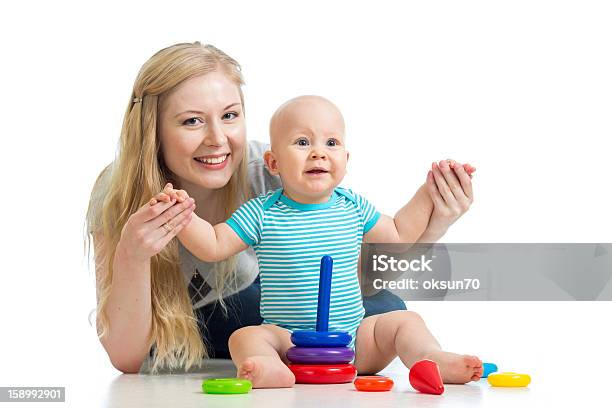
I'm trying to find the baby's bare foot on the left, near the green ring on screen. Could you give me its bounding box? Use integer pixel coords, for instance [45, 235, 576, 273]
[236, 356, 295, 388]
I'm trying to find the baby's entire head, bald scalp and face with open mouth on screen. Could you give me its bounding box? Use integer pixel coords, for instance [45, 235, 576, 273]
[265, 96, 348, 203]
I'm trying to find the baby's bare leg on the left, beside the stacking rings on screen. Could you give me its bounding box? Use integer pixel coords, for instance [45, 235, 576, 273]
[229, 324, 295, 388]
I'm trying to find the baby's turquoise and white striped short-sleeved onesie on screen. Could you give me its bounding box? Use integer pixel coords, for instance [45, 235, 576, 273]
[226, 188, 380, 347]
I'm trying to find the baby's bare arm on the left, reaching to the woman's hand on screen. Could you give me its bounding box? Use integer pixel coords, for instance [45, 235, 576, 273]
[149, 185, 248, 262]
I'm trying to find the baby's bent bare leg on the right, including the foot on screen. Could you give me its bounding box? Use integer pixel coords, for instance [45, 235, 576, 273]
[355, 310, 482, 384]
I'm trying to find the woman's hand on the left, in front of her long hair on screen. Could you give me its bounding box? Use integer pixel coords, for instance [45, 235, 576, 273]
[117, 185, 195, 261]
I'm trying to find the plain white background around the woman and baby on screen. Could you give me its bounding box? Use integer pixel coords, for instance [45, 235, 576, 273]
[0, 1, 612, 404]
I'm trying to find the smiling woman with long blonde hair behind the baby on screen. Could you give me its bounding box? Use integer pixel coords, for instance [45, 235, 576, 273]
[87, 42, 471, 373]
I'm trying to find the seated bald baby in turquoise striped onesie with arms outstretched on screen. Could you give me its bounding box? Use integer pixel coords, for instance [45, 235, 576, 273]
[152, 96, 482, 388]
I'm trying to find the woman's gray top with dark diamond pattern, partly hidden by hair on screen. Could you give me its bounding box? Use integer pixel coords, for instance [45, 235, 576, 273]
[88, 141, 281, 309]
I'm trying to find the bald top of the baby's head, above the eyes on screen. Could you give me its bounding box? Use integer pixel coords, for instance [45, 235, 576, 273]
[270, 95, 344, 150]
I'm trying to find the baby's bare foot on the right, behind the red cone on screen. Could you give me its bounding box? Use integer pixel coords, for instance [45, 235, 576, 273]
[425, 350, 482, 384]
